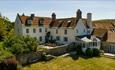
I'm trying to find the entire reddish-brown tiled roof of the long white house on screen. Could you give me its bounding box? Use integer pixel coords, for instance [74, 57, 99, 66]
[19, 16, 87, 27]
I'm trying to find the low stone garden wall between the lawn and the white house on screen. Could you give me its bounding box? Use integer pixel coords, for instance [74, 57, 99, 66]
[17, 45, 69, 64]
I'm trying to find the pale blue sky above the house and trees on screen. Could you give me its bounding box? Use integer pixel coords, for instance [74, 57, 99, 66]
[0, 0, 115, 21]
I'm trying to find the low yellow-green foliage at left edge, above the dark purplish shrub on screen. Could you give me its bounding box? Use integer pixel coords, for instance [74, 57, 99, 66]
[0, 42, 12, 61]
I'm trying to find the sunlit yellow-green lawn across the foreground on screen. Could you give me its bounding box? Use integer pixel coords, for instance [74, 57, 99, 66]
[23, 56, 115, 70]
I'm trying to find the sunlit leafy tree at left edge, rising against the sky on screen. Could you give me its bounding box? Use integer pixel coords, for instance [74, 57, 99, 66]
[0, 17, 14, 41]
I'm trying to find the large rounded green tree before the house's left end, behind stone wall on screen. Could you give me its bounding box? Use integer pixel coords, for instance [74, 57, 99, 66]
[4, 35, 38, 55]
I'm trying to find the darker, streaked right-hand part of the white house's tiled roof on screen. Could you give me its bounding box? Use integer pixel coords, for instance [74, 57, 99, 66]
[50, 17, 87, 27]
